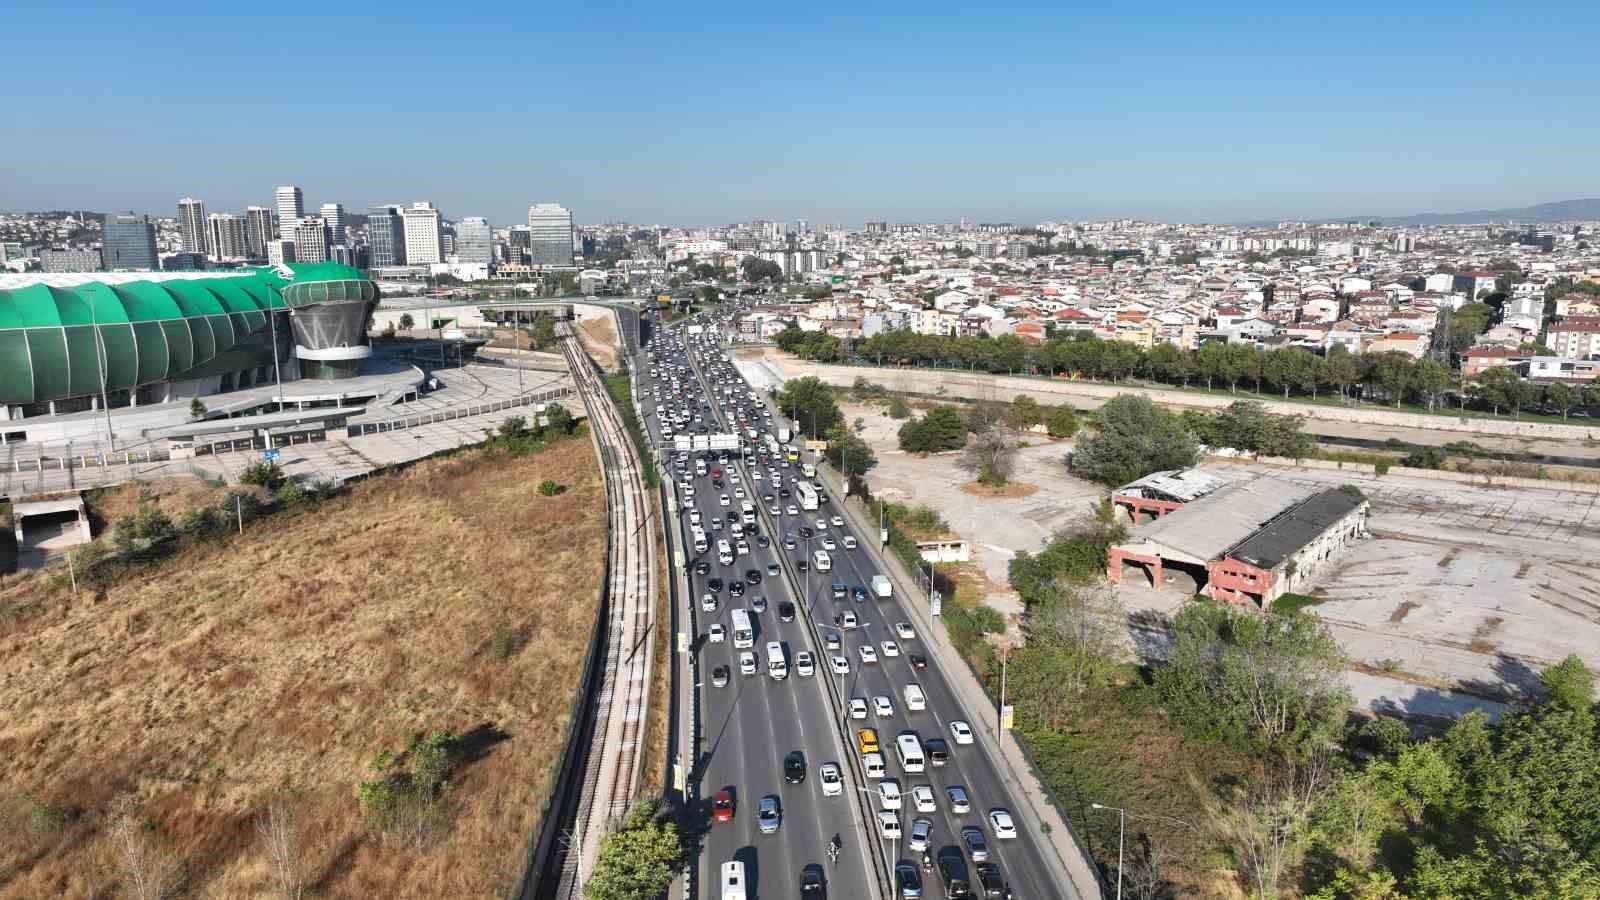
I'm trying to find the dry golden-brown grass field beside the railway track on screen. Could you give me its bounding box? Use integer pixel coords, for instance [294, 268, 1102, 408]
[0, 437, 605, 898]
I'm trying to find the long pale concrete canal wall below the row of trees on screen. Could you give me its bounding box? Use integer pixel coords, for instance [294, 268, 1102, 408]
[764, 357, 1600, 440]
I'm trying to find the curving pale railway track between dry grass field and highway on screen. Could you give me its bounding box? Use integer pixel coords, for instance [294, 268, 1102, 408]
[549, 323, 656, 900]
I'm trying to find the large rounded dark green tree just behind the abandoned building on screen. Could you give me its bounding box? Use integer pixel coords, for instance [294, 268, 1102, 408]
[1070, 394, 1200, 487]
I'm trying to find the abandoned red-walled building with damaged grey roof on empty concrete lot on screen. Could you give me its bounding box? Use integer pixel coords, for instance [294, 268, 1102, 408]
[1106, 472, 1368, 609]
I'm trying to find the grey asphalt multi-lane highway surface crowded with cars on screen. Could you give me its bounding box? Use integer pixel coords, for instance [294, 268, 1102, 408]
[638, 310, 1074, 898]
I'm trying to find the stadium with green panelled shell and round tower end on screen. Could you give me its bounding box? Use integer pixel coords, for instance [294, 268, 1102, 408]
[0, 263, 379, 431]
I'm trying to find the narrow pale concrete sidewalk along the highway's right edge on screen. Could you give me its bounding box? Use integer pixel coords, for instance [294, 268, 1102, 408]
[818, 466, 1101, 900]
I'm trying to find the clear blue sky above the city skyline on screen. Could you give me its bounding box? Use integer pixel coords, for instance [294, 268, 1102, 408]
[0, 0, 1600, 224]
